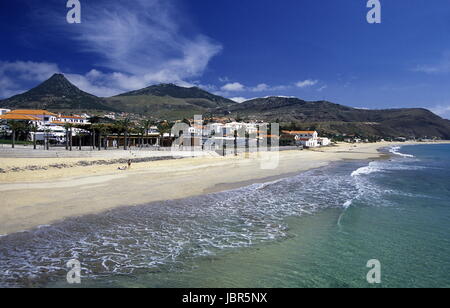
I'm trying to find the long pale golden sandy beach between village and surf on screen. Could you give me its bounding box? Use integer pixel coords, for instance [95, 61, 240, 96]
[0, 142, 448, 235]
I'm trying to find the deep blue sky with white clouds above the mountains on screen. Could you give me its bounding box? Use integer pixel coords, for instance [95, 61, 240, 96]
[0, 0, 450, 118]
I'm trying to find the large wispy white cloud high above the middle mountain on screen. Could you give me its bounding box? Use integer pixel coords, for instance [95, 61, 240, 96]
[69, 0, 222, 84]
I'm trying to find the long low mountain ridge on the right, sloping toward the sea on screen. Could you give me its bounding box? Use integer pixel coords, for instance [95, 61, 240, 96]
[219, 97, 450, 139]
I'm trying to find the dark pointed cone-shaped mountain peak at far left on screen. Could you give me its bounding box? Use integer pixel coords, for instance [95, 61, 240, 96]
[0, 74, 115, 111]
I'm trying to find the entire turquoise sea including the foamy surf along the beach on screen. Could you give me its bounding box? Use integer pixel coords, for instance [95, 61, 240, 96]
[0, 145, 450, 287]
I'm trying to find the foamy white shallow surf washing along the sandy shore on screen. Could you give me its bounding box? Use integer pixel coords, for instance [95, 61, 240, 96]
[0, 163, 412, 286]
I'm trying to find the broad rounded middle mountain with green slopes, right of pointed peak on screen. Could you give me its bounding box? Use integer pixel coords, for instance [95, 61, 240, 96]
[106, 84, 236, 120]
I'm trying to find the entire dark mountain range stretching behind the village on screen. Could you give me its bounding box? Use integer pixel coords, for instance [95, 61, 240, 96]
[0, 74, 450, 139]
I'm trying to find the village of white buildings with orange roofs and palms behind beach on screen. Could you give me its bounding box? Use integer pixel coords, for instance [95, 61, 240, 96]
[0, 109, 336, 155]
